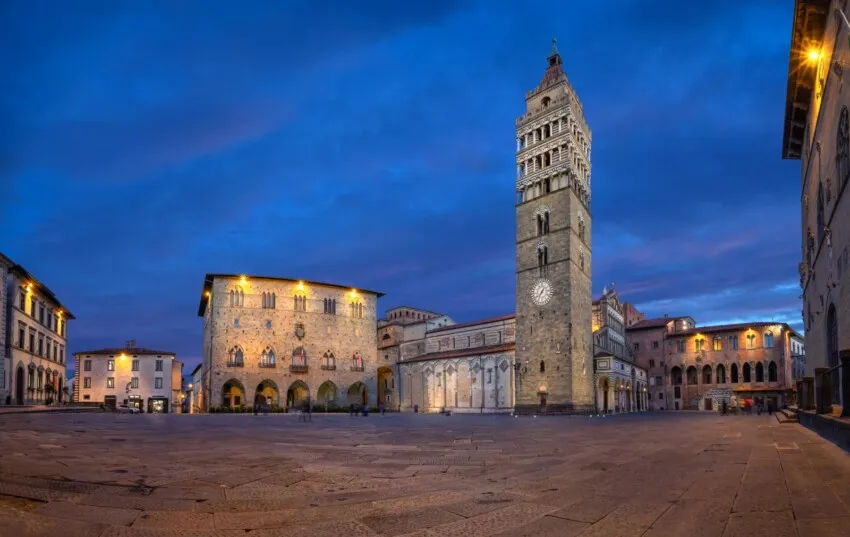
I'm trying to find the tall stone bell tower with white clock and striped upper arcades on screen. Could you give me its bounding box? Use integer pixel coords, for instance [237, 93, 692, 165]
[515, 39, 595, 414]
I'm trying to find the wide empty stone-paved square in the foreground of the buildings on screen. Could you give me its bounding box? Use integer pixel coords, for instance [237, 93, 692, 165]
[0, 413, 850, 537]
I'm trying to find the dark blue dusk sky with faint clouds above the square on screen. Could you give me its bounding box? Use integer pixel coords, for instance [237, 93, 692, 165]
[0, 0, 801, 367]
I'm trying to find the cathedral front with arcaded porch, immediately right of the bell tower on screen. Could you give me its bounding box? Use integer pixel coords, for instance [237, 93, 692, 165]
[593, 284, 649, 414]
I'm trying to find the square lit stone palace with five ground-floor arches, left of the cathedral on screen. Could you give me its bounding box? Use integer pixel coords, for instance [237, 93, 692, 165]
[198, 274, 380, 408]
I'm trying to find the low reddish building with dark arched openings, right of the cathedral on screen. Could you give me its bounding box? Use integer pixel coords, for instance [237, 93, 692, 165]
[628, 317, 802, 411]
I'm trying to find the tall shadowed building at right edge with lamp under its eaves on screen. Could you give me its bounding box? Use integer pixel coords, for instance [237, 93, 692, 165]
[782, 0, 850, 414]
